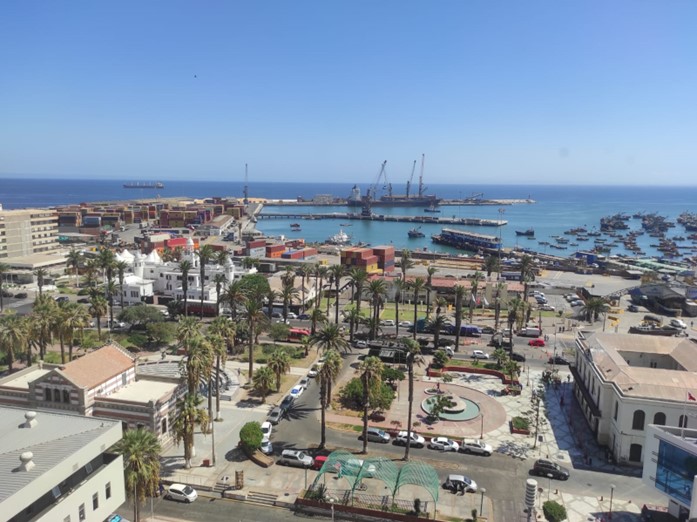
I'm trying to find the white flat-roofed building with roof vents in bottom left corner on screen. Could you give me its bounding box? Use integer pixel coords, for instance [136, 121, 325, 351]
[0, 407, 126, 522]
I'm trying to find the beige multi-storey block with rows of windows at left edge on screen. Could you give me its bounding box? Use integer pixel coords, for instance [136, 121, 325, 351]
[0, 209, 59, 259]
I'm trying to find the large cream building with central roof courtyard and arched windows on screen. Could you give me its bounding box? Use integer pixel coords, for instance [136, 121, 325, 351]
[570, 333, 697, 466]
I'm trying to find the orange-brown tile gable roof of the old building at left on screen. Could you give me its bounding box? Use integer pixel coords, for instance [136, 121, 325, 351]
[61, 343, 135, 389]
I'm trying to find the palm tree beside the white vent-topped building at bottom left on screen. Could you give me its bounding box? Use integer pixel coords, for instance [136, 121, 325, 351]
[114, 428, 162, 522]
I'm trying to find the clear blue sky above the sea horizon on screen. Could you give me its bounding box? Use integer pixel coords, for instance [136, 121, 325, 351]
[0, 0, 697, 185]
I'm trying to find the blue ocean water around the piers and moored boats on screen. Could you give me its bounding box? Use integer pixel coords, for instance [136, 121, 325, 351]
[0, 179, 697, 256]
